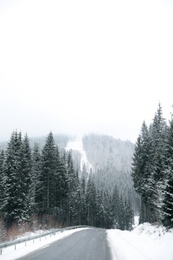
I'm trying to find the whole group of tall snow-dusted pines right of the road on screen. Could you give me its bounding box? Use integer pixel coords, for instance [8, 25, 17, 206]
[132, 104, 173, 228]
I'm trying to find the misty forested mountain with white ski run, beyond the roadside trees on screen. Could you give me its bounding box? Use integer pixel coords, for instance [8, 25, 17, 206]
[66, 134, 139, 211]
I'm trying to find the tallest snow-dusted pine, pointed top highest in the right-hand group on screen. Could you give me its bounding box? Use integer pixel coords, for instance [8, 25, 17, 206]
[149, 104, 167, 222]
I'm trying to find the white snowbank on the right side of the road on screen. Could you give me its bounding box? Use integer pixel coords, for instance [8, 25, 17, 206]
[107, 223, 173, 260]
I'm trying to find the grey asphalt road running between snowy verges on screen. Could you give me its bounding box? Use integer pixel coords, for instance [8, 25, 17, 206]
[16, 228, 111, 260]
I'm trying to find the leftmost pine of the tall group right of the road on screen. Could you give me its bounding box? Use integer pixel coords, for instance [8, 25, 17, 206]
[132, 122, 152, 223]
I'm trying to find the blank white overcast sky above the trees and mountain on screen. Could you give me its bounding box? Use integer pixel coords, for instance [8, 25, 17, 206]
[0, 0, 173, 142]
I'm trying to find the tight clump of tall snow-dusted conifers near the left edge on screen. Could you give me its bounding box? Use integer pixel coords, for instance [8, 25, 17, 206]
[3, 131, 30, 226]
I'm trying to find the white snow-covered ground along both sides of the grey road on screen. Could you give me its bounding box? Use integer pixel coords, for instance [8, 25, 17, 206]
[0, 223, 173, 260]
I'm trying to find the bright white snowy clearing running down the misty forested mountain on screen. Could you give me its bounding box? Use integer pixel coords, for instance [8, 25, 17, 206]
[65, 140, 93, 173]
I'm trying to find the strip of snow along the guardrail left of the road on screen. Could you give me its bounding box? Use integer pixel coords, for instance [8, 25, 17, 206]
[0, 228, 86, 260]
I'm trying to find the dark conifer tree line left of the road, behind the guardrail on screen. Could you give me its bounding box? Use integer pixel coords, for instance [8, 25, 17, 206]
[0, 131, 133, 241]
